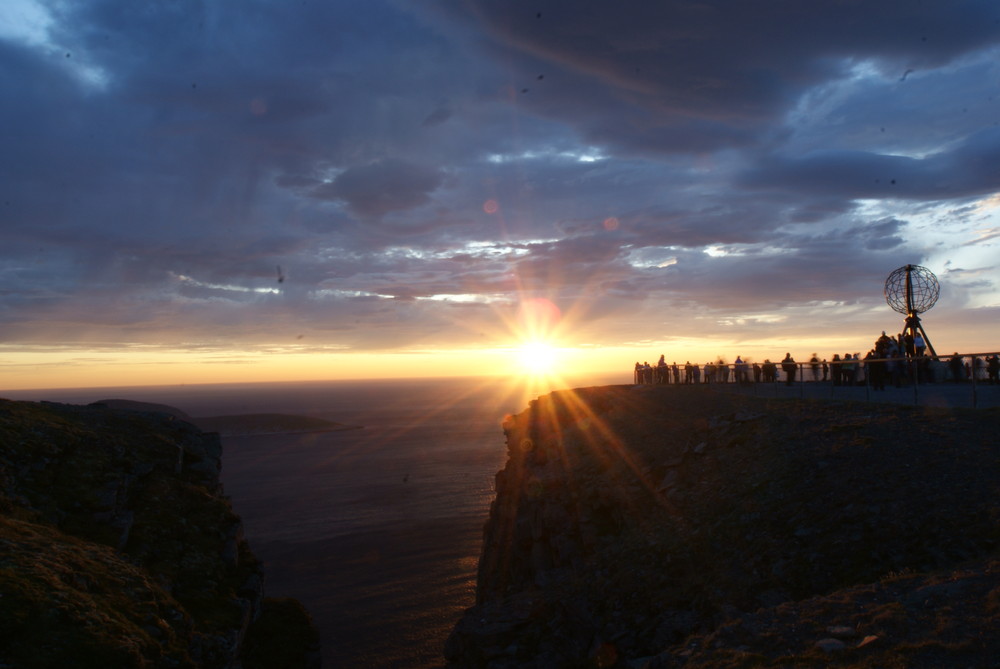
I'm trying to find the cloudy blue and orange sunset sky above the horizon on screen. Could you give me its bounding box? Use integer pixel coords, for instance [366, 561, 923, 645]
[0, 0, 1000, 389]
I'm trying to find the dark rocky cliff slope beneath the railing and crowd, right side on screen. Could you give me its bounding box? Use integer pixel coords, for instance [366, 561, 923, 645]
[446, 386, 1000, 668]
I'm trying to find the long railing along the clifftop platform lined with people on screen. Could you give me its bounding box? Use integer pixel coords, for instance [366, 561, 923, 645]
[634, 351, 1000, 408]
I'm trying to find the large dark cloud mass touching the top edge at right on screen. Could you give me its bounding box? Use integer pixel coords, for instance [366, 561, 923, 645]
[434, 0, 997, 152]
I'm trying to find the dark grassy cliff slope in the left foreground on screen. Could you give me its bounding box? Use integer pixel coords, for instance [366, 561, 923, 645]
[0, 400, 318, 669]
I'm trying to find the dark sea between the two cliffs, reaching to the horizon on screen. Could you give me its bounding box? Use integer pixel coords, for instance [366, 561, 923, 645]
[0, 377, 629, 669]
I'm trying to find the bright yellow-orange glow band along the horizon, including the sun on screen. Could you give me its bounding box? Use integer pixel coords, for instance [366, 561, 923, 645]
[0, 318, 995, 396]
